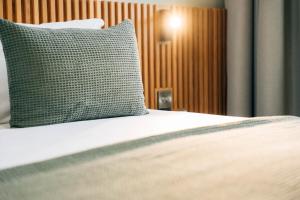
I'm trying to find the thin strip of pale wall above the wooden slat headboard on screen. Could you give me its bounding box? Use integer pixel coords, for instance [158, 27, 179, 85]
[128, 0, 224, 7]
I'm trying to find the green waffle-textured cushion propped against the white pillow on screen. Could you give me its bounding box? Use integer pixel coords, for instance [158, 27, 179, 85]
[0, 20, 148, 127]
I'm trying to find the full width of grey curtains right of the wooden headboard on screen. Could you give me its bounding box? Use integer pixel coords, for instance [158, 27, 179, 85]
[225, 0, 300, 116]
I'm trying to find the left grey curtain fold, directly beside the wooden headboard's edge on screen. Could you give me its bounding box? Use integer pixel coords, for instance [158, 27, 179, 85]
[225, 0, 253, 116]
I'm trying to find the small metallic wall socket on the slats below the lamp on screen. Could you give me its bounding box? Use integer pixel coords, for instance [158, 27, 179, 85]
[156, 88, 172, 110]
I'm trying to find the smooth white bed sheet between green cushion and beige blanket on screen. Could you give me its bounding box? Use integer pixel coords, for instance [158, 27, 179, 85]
[0, 110, 245, 169]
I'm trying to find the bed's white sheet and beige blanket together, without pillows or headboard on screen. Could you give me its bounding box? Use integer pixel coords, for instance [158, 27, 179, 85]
[0, 110, 300, 200]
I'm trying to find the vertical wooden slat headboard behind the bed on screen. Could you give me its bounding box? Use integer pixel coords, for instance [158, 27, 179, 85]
[0, 0, 226, 114]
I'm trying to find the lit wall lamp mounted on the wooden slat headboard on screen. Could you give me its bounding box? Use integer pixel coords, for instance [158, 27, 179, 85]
[158, 9, 183, 42]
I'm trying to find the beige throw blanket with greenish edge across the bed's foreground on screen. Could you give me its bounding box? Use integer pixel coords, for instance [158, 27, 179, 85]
[0, 117, 300, 200]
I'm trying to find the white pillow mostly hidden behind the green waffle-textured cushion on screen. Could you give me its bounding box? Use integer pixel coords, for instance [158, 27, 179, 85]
[0, 19, 104, 124]
